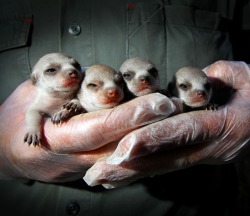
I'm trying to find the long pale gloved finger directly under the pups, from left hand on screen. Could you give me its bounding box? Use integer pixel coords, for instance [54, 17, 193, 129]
[45, 93, 175, 153]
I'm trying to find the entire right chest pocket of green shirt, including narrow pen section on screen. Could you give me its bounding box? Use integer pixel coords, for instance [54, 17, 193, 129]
[126, 2, 233, 87]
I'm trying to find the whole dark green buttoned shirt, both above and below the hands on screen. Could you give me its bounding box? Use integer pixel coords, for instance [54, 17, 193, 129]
[0, 0, 249, 216]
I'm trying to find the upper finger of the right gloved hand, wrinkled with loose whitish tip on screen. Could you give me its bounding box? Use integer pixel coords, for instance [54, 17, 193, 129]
[107, 109, 227, 164]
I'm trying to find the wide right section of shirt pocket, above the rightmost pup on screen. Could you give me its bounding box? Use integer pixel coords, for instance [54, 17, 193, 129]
[165, 5, 233, 80]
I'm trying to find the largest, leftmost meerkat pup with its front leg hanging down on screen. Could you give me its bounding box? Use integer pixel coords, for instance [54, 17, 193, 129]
[24, 53, 82, 146]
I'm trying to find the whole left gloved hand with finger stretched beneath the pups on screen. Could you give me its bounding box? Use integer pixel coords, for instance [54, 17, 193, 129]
[0, 81, 175, 182]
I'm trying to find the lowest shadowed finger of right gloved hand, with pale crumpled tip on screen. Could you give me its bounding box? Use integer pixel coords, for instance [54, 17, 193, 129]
[83, 144, 211, 189]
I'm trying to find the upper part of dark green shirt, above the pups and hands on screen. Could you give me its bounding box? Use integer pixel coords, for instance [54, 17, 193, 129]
[0, 0, 250, 102]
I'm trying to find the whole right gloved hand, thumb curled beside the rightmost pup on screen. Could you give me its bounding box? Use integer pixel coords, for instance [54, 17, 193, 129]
[84, 61, 250, 188]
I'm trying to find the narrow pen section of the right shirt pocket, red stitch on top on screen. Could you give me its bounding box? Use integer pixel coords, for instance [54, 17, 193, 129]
[126, 2, 166, 86]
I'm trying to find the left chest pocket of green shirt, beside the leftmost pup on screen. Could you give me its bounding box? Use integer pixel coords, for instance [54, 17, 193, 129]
[0, 14, 32, 103]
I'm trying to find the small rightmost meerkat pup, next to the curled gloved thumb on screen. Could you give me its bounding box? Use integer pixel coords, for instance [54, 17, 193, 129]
[168, 67, 217, 111]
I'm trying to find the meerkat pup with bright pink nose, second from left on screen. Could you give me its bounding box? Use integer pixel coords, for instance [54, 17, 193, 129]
[64, 64, 124, 115]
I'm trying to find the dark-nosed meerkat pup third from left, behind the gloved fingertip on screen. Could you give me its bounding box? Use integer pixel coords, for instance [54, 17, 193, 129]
[119, 57, 164, 98]
